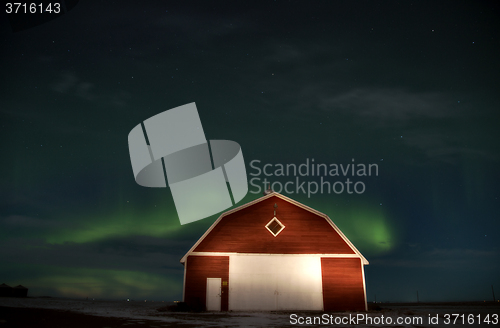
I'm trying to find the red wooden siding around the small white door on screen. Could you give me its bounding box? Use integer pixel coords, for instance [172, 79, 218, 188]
[184, 255, 229, 311]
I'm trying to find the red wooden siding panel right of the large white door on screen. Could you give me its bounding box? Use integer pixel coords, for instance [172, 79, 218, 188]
[321, 258, 365, 311]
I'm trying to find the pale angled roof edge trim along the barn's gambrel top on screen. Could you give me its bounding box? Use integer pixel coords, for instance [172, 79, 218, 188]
[180, 192, 369, 265]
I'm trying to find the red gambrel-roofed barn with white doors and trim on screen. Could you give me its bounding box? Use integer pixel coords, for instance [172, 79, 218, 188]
[181, 191, 368, 311]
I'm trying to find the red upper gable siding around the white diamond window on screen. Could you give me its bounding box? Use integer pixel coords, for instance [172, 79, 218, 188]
[194, 196, 359, 255]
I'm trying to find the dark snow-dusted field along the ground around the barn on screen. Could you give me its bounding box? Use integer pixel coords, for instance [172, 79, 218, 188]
[0, 298, 500, 327]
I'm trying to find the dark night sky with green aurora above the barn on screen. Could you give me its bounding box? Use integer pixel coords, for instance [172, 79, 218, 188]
[0, 0, 500, 301]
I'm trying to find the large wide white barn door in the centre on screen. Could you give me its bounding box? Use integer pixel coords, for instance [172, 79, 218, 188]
[229, 255, 323, 311]
